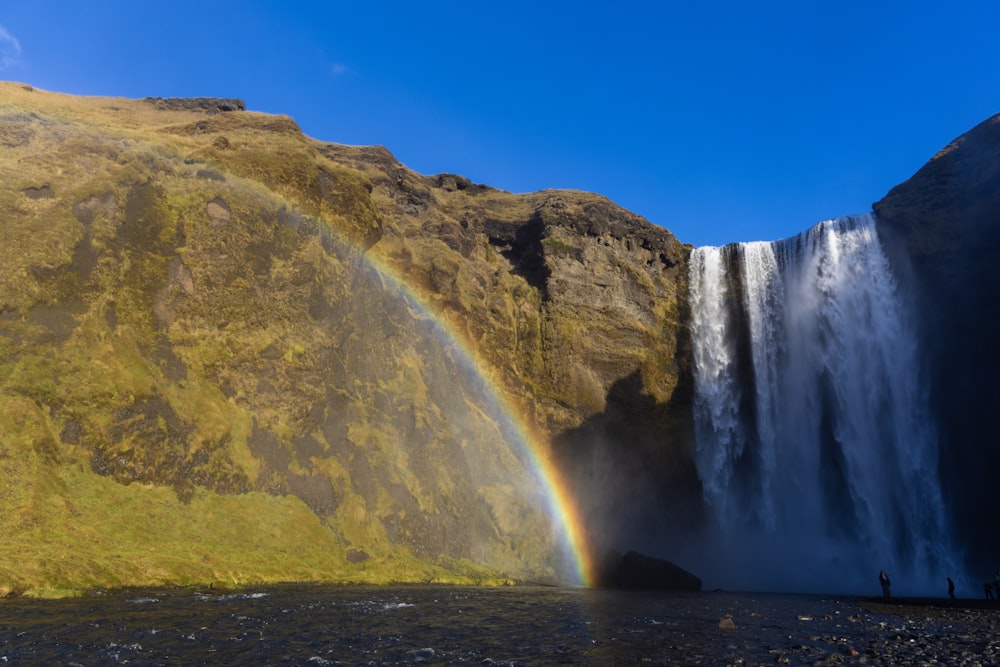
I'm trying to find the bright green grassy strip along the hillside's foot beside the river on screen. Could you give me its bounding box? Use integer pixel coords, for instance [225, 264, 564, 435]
[0, 403, 503, 596]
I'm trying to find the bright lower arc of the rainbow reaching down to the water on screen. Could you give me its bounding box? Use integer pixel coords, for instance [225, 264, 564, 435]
[361, 252, 594, 587]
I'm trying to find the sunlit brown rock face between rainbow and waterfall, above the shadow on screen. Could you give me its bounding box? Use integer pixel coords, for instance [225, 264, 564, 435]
[321, 144, 688, 434]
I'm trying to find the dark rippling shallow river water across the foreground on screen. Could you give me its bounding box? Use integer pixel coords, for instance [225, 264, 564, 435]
[0, 585, 1000, 665]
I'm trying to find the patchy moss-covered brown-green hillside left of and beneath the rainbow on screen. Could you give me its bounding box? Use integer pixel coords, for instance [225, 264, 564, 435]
[0, 85, 553, 590]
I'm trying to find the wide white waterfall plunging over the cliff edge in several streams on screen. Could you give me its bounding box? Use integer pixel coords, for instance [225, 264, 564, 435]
[690, 214, 959, 594]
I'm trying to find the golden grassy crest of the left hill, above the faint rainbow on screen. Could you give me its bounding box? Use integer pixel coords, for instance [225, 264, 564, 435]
[0, 82, 381, 253]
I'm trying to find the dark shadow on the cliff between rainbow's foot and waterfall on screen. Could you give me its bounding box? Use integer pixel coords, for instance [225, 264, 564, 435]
[553, 372, 705, 576]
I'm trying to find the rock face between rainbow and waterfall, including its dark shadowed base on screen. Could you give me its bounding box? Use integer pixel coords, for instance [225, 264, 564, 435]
[316, 145, 702, 550]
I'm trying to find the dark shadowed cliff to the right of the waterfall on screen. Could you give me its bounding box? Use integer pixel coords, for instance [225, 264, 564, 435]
[873, 115, 1000, 576]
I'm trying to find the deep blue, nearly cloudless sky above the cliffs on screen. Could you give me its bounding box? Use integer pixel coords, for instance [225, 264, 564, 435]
[0, 0, 1000, 245]
